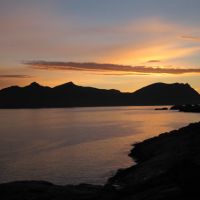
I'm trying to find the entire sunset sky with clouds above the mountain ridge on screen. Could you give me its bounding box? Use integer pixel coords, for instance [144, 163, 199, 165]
[0, 0, 200, 92]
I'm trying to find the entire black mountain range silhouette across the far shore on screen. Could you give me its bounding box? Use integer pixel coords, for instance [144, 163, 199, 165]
[0, 82, 200, 108]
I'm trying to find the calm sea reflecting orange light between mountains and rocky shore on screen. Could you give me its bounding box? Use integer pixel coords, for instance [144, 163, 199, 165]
[0, 107, 200, 184]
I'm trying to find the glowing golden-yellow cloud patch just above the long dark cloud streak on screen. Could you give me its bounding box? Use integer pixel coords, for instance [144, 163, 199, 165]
[106, 40, 200, 65]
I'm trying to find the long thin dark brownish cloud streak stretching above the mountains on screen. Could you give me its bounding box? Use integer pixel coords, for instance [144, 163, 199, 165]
[24, 61, 200, 75]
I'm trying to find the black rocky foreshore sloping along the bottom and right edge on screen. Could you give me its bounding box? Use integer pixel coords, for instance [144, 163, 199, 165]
[0, 122, 200, 200]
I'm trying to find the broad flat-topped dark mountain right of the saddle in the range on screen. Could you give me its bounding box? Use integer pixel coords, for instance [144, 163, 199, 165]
[128, 83, 200, 105]
